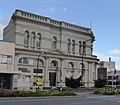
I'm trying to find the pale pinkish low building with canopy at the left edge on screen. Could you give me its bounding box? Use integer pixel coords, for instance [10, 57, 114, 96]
[0, 41, 19, 89]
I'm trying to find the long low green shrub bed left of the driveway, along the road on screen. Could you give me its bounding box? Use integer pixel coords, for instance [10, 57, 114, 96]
[0, 90, 76, 97]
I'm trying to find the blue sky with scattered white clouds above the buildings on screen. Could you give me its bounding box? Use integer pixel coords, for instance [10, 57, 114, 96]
[0, 0, 120, 69]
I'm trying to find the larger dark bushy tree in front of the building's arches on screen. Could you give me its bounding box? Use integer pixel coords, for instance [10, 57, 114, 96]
[65, 76, 84, 89]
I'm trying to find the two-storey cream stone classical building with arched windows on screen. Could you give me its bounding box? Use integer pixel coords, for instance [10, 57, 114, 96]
[3, 10, 99, 89]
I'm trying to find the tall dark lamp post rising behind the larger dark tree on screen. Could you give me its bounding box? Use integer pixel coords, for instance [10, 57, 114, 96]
[81, 37, 95, 83]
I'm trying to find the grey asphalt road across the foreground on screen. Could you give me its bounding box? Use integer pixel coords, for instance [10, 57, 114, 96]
[0, 95, 120, 105]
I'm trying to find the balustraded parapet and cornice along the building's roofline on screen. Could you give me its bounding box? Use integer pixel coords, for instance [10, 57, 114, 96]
[12, 10, 93, 36]
